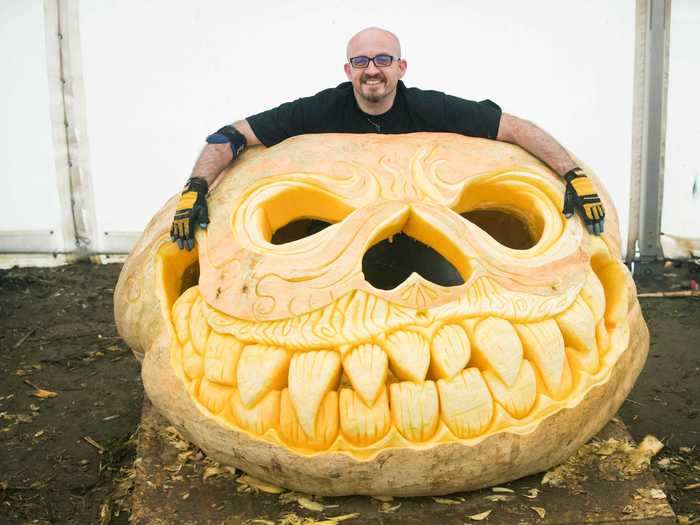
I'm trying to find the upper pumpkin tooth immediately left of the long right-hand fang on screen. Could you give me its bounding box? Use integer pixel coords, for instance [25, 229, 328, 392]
[467, 317, 523, 386]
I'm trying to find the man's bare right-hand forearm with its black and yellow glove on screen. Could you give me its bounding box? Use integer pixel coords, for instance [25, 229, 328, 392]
[496, 113, 605, 235]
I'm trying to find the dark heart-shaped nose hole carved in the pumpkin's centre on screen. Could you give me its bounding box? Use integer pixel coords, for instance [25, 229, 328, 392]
[362, 232, 464, 290]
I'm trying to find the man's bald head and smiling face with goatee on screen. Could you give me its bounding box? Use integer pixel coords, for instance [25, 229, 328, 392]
[345, 28, 406, 113]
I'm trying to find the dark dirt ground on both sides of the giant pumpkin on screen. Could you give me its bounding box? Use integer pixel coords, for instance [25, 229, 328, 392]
[0, 264, 700, 525]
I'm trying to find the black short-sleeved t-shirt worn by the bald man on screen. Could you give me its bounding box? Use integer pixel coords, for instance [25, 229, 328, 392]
[247, 81, 501, 146]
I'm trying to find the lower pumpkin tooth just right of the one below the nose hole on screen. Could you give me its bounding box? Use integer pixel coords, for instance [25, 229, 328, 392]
[438, 368, 493, 438]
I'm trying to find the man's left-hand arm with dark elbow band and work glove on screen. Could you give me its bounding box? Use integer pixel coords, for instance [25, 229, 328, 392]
[170, 120, 260, 250]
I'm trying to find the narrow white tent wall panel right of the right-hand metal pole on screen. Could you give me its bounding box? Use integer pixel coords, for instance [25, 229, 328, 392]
[661, 0, 700, 258]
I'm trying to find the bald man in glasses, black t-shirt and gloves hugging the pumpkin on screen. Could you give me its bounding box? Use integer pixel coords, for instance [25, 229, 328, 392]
[171, 27, 605, 250]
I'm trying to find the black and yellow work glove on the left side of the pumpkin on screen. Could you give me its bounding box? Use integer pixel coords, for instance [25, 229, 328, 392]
[170, 177, 209, 251]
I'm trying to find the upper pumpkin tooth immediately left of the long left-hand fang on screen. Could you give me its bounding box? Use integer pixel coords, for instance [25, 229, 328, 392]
[236, 345, 291, 408]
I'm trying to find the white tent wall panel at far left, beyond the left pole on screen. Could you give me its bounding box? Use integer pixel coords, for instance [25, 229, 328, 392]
[0, 0, 65, 253]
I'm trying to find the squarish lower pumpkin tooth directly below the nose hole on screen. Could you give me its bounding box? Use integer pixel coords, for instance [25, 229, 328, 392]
[389, 381, 440, 441]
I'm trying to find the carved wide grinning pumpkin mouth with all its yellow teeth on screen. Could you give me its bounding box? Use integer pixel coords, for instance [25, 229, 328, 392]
[164, 244, 629, 458]
